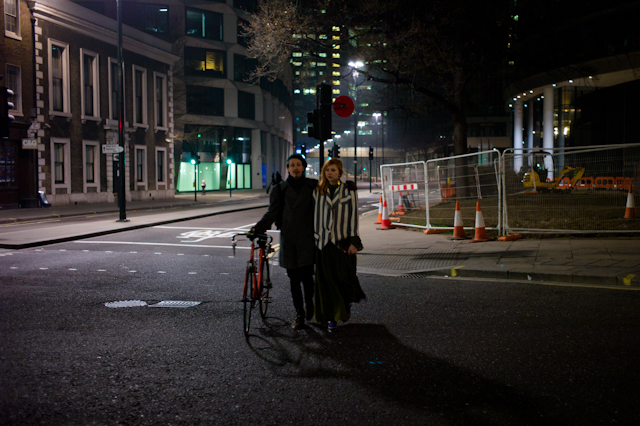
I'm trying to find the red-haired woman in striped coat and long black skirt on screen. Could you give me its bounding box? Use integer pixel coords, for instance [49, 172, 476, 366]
[313, 158, 366, 331]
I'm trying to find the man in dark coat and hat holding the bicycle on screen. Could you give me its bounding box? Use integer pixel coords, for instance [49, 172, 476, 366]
[252, 154, 318, 329]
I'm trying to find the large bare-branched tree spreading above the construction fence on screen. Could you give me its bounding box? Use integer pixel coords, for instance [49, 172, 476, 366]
[245, 0, 508, 161]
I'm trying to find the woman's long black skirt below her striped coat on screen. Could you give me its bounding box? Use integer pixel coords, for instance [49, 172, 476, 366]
[314, 243, 366, 323]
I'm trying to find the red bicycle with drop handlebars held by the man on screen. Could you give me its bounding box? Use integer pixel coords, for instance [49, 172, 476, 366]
[231, 233, 274, 336]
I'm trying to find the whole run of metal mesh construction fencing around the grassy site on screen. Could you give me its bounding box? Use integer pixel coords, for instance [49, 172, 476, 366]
[380, 144, 640, 235]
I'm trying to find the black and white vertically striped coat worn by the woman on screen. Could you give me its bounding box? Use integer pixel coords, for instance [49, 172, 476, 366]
[313, 182, 359, 250]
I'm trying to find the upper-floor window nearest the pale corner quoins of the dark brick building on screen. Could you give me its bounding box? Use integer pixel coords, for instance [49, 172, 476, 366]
[49, 40, 70, 114]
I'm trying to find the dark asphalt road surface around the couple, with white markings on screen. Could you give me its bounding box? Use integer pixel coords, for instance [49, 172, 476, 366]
[0, 211, 640, 425]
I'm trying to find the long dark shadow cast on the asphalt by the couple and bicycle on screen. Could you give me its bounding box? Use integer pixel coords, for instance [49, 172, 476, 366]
[248, 320, 568, 425]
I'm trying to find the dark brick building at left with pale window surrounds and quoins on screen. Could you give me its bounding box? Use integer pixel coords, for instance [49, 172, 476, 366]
[0, 0, 178, 207]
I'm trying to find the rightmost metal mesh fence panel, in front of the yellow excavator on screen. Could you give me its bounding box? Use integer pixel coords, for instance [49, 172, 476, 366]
[502, 144, 640, 233]
